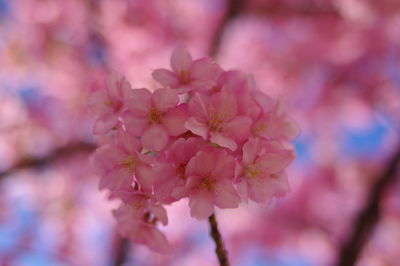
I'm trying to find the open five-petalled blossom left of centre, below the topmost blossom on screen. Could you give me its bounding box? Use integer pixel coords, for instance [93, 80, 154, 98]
[122, 89, 188, 151]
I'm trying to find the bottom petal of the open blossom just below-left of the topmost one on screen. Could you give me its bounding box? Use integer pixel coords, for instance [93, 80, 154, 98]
[141, 124, 169, 151]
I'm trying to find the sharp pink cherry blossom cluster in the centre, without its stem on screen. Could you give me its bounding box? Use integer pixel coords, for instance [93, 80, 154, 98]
[89, 48, 298, 252]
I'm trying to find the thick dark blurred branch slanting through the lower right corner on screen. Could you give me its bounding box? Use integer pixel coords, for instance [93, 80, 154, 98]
[337, 147, 400, 266]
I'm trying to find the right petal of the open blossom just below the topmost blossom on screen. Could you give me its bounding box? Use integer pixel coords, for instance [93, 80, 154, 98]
[162, 104, 188, 136]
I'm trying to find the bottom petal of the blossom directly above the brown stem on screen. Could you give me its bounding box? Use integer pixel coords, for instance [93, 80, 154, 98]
[189, 191, 214, 220]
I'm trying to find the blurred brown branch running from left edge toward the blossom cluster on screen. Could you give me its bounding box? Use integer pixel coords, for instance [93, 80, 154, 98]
[0, 142, 96, 180]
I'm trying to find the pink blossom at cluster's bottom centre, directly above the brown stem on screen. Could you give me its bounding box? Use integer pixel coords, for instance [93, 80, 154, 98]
[173, 148, 240, 220]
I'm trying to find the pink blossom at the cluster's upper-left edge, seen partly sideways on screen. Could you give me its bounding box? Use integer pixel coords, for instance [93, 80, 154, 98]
[88, 73, 131, 135]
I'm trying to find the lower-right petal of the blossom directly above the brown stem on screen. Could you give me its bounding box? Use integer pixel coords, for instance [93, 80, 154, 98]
[213, 179, 240, 209]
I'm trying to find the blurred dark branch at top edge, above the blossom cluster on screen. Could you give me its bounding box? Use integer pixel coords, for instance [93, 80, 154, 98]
[209, 0, 244, 57]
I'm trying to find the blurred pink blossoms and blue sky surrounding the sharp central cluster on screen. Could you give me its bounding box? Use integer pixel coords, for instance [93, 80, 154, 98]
[0, 0, 400, 266]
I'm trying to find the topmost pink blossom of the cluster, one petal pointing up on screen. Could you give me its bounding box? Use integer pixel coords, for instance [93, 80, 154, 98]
[153, 48, 222, 93]
